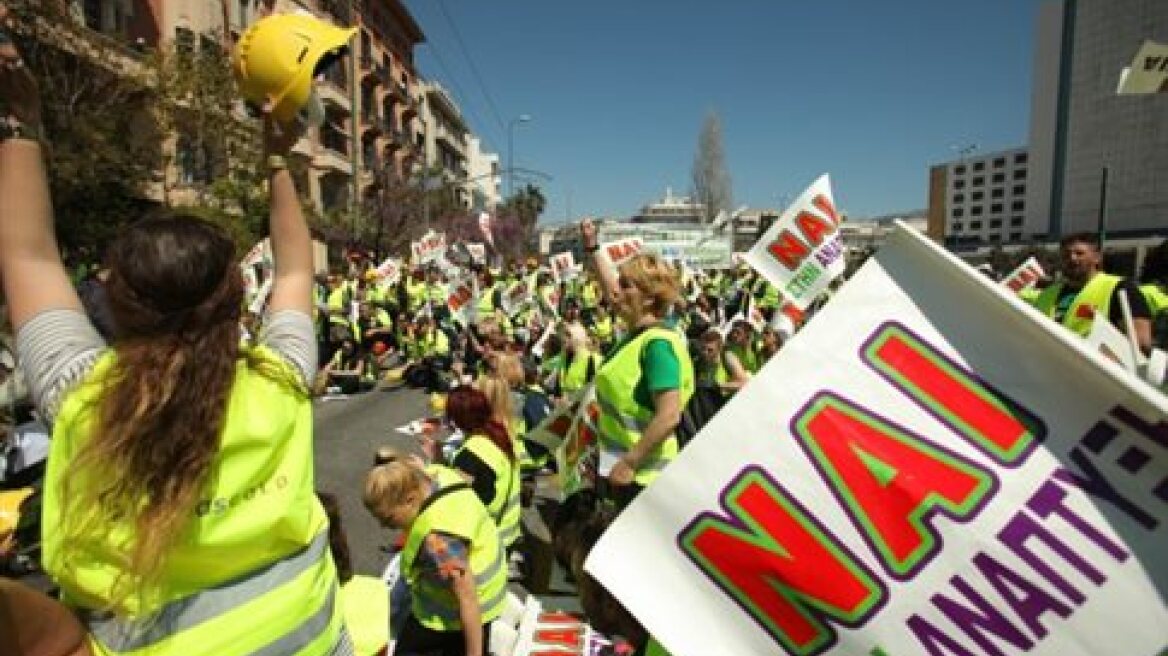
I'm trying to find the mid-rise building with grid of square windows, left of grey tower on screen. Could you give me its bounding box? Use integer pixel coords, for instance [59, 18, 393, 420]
[926, 148, 1045, 247]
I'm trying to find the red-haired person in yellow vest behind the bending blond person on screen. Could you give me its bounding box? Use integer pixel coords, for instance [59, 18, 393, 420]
[446, 385, 521, 547]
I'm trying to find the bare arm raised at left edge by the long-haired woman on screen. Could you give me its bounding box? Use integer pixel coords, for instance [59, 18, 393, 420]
[0, 14, 83, 330]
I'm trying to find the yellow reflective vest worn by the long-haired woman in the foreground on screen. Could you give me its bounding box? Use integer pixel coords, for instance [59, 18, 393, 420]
[42, 347, 348, 656]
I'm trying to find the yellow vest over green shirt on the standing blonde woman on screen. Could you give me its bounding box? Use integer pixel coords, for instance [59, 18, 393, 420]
[596, 326, 694, 486]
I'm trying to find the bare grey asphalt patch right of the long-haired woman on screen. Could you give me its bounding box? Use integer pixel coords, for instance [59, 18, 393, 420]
[313, 388, 430, 575]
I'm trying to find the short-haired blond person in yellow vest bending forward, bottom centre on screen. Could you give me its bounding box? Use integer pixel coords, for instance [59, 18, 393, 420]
[364, 455, 507, 656]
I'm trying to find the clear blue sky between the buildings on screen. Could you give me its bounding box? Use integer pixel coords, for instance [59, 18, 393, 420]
[405, 0, 1040, 223]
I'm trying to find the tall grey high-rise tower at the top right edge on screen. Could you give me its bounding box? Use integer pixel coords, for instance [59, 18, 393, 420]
[1027, 0, 1168, 238]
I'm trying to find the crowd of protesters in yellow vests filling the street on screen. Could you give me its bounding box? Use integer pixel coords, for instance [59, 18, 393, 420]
[0, 3, 1168, 656]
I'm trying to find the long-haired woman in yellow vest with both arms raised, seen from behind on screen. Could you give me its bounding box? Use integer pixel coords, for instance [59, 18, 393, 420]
[0, 6, 350, 655]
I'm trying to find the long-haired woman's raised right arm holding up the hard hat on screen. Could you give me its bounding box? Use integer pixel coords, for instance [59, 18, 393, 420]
[264, 116, 313, 316]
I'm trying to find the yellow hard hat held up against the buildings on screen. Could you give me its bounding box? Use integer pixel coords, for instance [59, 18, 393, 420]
[231, 14, 357, 124]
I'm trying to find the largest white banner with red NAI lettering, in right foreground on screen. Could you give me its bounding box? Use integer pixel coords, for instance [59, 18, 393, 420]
[585, 224, 1168, 656]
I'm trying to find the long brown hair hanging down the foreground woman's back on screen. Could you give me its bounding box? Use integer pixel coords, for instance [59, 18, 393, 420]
[62, 216, 243, 610]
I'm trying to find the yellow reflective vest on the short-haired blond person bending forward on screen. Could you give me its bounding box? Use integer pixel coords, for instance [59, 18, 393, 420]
[402, 466, 507, 631]
